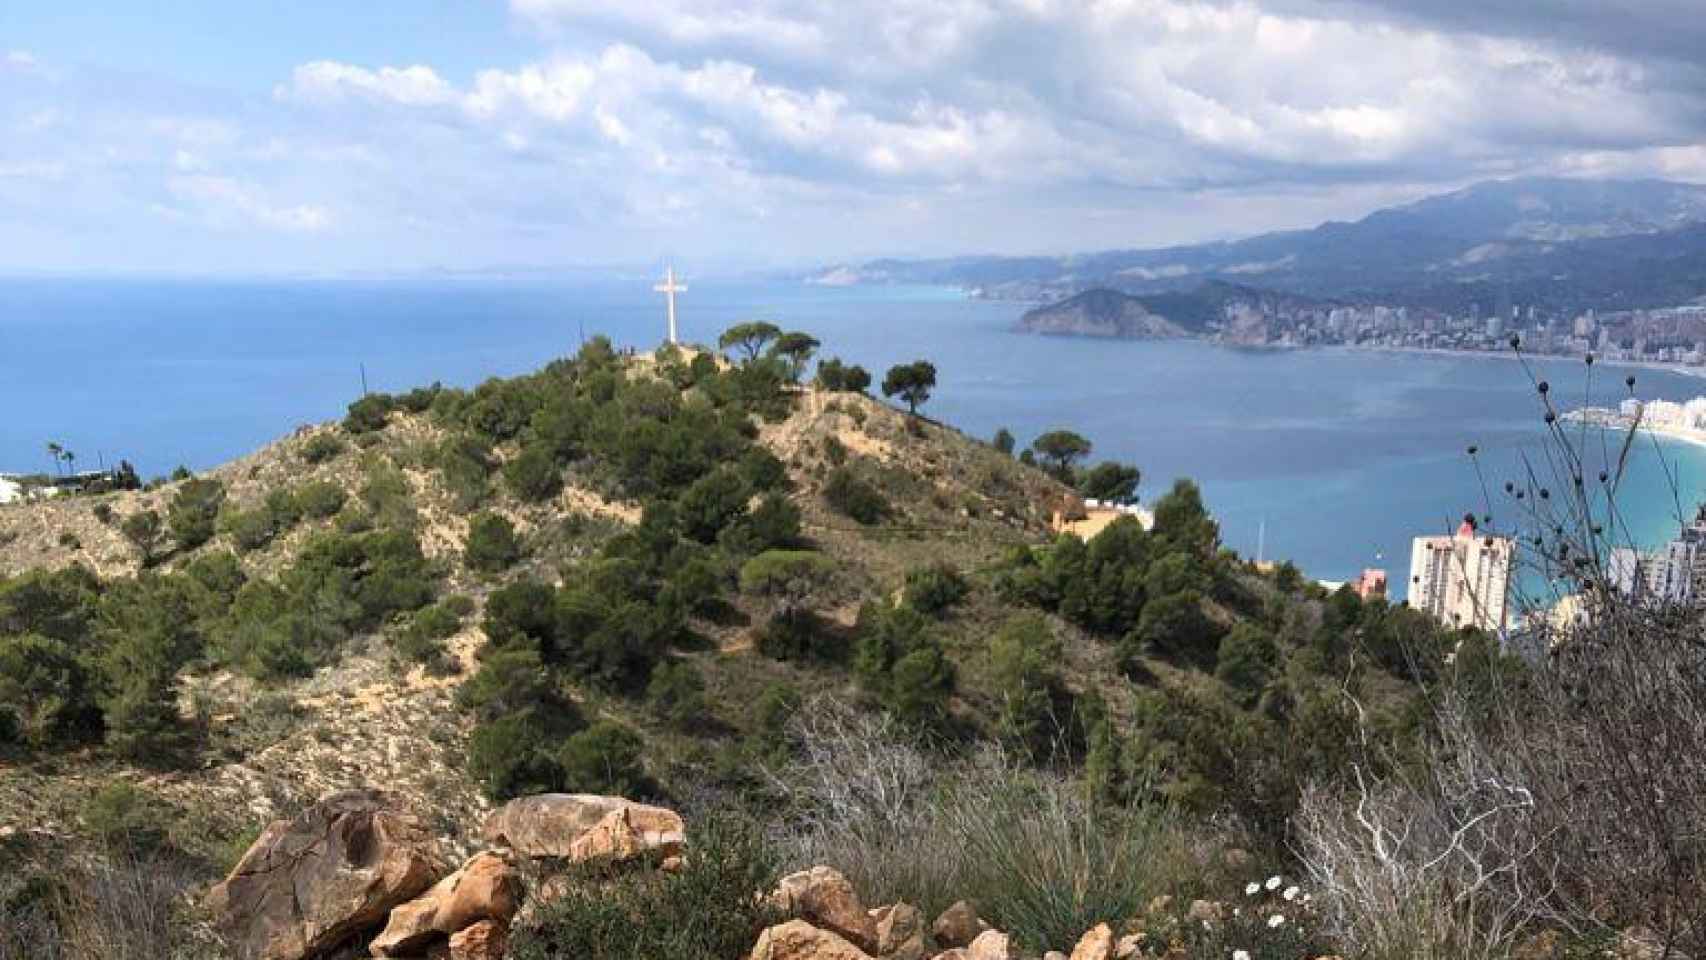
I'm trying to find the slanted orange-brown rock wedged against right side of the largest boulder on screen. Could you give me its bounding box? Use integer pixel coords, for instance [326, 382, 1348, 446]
[368, 851, 522, 957]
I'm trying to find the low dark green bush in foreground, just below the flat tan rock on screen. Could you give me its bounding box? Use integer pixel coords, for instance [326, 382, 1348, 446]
[508, 817, 781, 960]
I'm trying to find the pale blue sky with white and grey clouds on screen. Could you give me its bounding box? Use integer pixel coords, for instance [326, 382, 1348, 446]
[0, 0, 1706, 275]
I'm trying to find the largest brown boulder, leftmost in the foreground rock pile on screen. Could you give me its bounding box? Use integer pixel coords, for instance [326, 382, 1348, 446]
[205, 789, 440, 960]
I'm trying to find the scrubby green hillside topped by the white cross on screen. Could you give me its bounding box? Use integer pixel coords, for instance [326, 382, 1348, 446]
[0, 327, 1569, 958]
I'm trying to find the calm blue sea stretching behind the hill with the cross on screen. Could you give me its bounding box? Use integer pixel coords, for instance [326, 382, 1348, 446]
[0, 276, 1706, 595]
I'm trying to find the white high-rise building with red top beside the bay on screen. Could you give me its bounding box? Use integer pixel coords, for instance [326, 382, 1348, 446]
[1409, 517, 1515, 633]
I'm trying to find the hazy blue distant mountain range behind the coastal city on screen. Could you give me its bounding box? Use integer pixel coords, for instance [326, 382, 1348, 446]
[810, 179, 1706, 315]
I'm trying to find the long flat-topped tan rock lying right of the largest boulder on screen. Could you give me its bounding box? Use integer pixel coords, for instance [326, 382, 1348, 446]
[481, 793, 688, 863]
